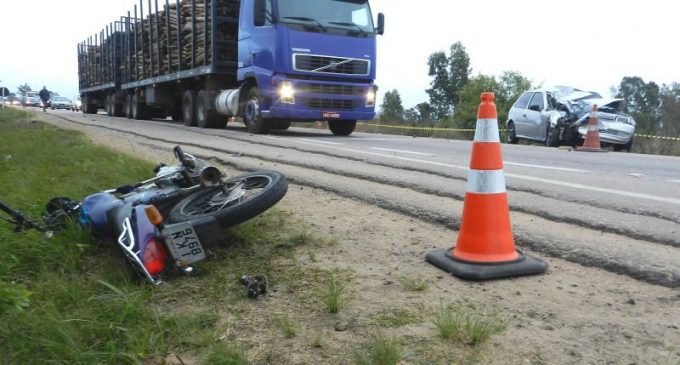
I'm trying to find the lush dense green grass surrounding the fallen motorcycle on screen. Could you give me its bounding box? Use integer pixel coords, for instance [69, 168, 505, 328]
[0, 109, 294, 364]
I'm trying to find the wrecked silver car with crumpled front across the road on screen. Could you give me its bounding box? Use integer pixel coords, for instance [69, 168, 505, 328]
[506, 87, 635, 152]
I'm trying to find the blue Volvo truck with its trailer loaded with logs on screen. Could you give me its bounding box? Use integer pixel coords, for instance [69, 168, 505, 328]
[78, 0, 385, 136]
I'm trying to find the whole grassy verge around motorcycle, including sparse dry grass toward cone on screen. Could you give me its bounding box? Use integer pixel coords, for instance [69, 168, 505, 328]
[0, 109, 504, 365]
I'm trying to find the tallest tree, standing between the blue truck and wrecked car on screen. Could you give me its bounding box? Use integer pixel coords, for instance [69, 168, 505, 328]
[426, 42, 472, 121]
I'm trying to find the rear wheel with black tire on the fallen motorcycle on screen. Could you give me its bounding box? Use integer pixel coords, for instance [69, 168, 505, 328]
[169, 171, 288, 228]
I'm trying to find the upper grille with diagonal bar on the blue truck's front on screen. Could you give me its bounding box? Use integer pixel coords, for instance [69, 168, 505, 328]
[293, 54, 370, 76]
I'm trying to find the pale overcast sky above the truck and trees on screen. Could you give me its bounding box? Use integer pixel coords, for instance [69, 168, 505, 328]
[0, 0, 680, 108]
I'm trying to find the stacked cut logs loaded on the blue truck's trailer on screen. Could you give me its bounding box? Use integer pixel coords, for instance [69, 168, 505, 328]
[79, 0, 240, 86]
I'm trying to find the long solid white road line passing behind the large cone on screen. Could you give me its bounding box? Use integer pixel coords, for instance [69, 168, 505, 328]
[258, 137, 680, 205]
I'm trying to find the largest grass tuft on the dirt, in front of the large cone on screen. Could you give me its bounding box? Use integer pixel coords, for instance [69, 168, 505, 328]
[432, 303, 506, 346]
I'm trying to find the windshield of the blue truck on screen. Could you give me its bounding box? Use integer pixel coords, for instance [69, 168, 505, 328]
[278, 0, 374, 35]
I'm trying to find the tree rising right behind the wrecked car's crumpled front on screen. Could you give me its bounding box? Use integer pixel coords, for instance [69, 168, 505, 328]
[616, 76, 661, 133]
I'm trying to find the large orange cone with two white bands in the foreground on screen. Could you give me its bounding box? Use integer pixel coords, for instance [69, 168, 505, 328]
[425, 93, 548, 280]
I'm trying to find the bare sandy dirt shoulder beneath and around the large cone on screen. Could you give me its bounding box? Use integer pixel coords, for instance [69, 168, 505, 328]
[34, 112, 680, 365]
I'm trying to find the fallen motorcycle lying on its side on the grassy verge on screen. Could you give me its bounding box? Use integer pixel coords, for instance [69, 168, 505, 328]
[0, 146, 288, 285]
